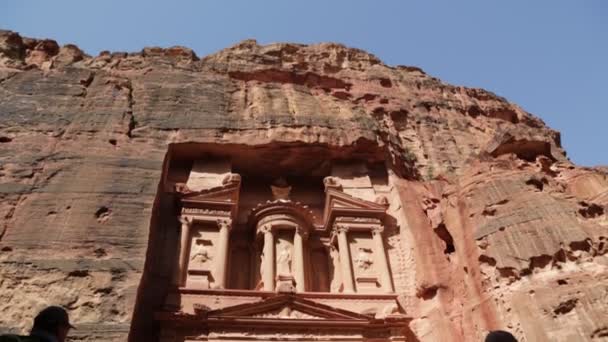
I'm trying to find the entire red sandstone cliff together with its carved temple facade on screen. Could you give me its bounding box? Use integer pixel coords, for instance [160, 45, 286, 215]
[0, 31, 608, 342]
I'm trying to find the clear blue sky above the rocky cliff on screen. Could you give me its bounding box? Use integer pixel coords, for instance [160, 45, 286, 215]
[0, 0, 608, 166]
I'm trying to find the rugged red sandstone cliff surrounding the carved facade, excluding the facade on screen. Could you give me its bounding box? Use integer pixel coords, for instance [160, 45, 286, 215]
[0, 31, 608, 341]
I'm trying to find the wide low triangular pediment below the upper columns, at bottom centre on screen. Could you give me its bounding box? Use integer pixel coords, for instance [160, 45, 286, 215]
[208, 295, 372, 321]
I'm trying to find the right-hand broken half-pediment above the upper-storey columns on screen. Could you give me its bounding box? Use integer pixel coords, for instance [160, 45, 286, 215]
[324, 189, 387, 227]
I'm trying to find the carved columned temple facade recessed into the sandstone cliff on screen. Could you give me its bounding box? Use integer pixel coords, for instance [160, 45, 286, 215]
[154, 156, 412, 342]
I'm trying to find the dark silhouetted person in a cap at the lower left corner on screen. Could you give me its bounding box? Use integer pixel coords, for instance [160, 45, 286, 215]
[0, 306, 74, 342]
